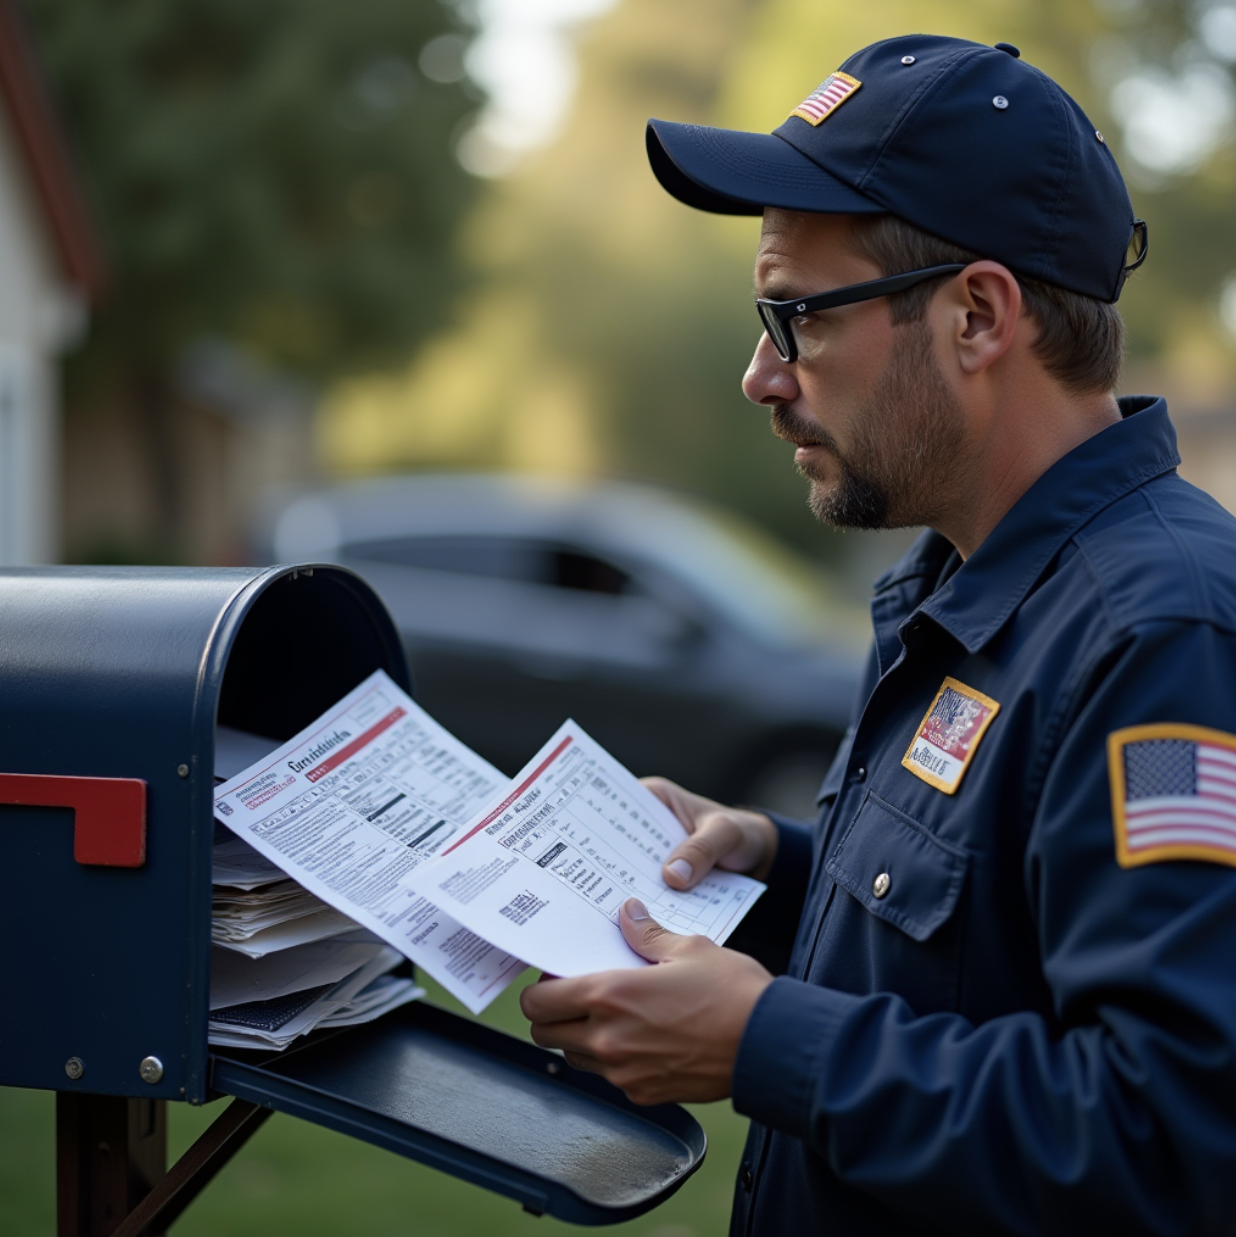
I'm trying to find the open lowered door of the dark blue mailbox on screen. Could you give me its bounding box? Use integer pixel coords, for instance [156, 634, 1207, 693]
[213, 1003, 704, 1225]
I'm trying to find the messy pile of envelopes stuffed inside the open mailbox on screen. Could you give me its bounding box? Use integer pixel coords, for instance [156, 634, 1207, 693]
[209, 727, 423, 1051]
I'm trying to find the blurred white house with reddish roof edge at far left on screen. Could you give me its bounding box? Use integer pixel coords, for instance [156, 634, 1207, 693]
[0, 0, 103, 563]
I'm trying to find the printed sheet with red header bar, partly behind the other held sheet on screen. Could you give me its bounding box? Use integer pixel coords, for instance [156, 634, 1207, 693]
[215, 670, 523, 1013]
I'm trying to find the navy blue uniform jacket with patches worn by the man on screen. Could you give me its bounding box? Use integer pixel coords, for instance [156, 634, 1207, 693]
[732, 398, 1236, 1237]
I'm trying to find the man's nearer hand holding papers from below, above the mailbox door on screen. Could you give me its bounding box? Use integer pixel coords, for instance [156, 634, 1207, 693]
[520, 895, 772, 1103]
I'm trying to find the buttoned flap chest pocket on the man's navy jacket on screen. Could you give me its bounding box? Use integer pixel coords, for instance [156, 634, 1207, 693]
[809, 793, 970, 1014]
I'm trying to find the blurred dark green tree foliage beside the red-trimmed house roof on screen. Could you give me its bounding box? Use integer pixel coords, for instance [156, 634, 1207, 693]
[25, 0, 475, 375]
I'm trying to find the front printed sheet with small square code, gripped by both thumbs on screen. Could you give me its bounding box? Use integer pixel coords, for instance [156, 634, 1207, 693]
[417, 721, 765, 975]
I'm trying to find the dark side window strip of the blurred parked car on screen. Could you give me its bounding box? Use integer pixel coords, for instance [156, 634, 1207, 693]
[348, 534, 631, 596]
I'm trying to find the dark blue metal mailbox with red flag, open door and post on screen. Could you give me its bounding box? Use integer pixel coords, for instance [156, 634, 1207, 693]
[0, 565, 704, 1237]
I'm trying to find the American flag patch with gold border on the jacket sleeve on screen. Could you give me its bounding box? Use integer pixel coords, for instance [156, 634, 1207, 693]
[1107, 722, 1236, 867]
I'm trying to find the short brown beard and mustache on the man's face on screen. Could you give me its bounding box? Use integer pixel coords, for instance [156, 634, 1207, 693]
[772, 323, 965, 528]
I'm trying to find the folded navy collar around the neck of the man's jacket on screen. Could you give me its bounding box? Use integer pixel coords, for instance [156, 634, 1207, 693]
[873, 396, 1180, 653]
